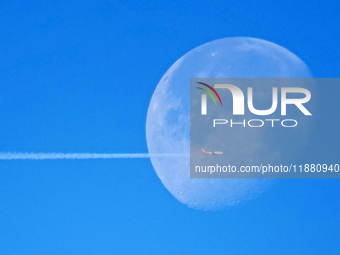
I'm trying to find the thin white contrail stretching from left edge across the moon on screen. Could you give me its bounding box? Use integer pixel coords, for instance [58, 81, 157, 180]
[0, 152, 188, 160]
